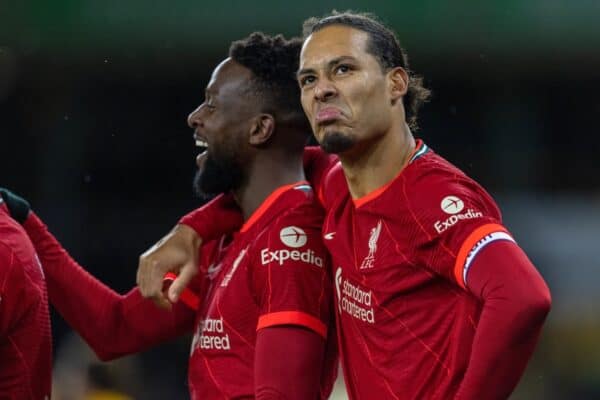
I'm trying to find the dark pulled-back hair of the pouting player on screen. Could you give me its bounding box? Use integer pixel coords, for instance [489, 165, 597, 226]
[303, 11, 431, 130]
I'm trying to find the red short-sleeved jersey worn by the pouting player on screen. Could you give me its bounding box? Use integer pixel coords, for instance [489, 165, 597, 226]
[323, 141, 512, 400]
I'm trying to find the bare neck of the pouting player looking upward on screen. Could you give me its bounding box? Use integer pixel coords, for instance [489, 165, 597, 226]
[340, 123, 415, 199]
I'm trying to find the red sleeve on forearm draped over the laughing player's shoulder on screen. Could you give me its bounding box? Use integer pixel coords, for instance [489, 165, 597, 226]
[179, 194, 244, 242]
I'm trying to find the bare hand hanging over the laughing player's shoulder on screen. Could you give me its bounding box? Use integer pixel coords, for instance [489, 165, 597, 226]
[137, 224, 202, 308]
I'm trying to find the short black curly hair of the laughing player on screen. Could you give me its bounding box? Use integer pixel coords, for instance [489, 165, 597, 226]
[229, 32, 310, 132]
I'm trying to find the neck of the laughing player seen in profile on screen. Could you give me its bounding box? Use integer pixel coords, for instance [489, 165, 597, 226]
[233, 150, 306, 221]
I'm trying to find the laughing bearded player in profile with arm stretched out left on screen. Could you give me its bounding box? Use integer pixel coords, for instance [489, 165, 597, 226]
[4, 33, 336, 399]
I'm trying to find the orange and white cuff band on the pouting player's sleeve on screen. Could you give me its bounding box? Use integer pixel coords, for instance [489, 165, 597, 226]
[454, 224, 515, 289]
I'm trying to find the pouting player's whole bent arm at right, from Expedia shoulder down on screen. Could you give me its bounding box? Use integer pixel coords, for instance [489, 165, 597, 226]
[404, 176, 550, 400]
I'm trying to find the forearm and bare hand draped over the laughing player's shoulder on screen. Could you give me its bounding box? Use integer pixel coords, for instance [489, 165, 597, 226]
[137, 195, 243, 307]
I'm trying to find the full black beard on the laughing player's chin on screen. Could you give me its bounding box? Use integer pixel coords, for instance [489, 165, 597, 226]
[194, 153, 244, 200]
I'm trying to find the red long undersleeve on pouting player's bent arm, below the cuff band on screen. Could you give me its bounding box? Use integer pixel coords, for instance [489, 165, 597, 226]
[456, 241, 551, 400]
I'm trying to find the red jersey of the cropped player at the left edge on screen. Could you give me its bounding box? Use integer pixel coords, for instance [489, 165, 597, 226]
[0, 205, 52, 400]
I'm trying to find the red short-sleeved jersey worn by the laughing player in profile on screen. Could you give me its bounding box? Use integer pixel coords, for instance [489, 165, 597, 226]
[189, 182, 336, 399]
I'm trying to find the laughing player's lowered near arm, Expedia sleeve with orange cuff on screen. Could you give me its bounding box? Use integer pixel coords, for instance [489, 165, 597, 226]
[252, 210, 332, 399]
